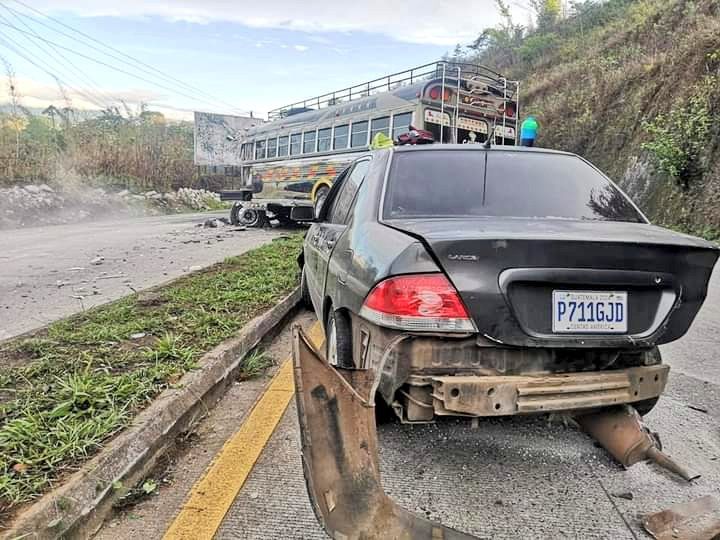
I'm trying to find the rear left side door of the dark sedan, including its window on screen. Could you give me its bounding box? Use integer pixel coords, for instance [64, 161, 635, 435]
[316, 156, 371, 312]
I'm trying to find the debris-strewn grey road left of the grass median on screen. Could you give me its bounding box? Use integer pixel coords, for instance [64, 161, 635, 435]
[0, 212, 278, 340]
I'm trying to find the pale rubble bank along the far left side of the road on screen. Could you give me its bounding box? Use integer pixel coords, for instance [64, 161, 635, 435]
[0, 184, 221, 229]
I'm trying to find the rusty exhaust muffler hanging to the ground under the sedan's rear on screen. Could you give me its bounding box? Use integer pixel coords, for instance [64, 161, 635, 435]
[575, 405, 700, 482]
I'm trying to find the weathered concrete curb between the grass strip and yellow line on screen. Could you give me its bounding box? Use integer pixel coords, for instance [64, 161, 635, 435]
[0, 288, 300, 539]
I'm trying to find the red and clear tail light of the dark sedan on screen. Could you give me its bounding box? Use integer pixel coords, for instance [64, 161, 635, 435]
[360, 274, 476, 332]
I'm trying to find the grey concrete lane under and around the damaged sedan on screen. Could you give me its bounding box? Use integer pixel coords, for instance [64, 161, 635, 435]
[99, 273, 720, 540]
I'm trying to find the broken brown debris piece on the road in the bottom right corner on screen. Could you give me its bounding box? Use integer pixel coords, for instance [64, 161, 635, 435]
[643, 495, 720, 540]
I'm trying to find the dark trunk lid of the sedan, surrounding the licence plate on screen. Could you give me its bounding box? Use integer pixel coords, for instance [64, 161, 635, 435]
[386, 218, 718, 347]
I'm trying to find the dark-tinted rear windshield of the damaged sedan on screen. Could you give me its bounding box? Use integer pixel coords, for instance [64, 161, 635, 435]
[383, 150, 644, 223]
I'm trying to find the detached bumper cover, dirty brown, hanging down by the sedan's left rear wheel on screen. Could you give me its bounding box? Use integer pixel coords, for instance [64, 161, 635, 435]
[293, 325, 476, 540]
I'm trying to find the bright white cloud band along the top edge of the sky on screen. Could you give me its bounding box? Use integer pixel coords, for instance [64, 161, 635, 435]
[23, 0, 519, 46]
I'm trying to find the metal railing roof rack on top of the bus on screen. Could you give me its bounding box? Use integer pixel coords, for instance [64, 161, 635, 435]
[268, 60, 515, 122]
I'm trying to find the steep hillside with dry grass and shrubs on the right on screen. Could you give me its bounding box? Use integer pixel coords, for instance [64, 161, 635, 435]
[464, 0, 720, 237]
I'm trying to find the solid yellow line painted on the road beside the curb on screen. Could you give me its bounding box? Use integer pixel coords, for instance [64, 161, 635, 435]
[163, 322, 324, 540]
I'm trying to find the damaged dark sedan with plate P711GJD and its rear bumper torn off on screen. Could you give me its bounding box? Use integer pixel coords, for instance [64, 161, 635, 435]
[301, 145, 718, 422]
